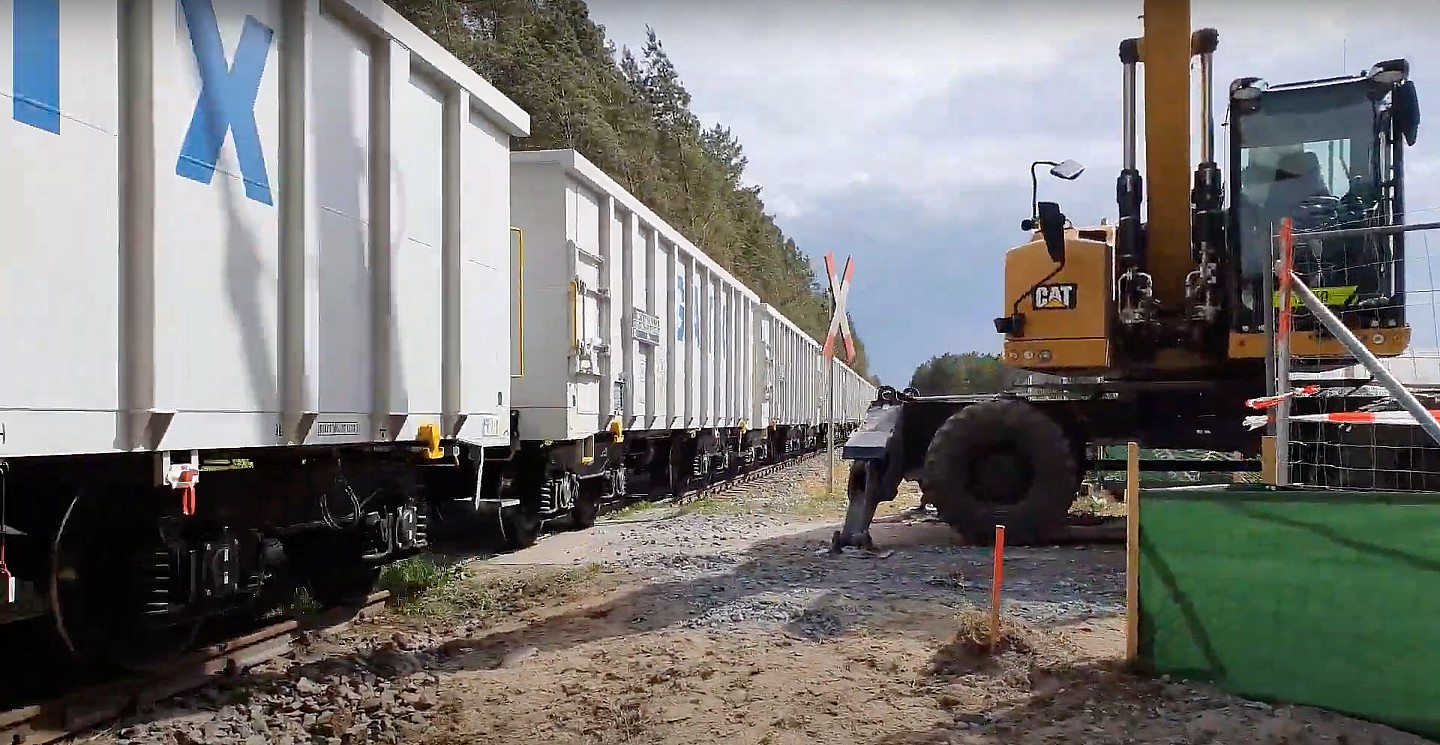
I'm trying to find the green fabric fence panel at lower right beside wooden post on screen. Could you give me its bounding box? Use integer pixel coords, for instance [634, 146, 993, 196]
[1139, 484, 1440, 739]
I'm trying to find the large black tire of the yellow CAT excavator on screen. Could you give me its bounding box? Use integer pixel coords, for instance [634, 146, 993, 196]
[922, 399, 1080, 545]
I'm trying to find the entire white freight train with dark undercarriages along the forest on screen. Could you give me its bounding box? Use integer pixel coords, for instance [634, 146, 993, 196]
[0, 0, 874, 667]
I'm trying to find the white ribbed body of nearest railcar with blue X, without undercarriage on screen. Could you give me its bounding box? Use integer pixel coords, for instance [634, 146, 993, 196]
[0, 0, 528, 457]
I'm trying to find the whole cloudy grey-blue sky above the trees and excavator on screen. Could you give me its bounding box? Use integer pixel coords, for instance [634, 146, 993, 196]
[589, 0, 1440, 385]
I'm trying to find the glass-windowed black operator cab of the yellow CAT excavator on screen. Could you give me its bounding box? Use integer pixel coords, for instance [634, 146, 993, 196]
[1225, 59, 1420, 357]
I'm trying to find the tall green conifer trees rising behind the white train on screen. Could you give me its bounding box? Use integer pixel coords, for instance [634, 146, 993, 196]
[389, 0, 870, 375]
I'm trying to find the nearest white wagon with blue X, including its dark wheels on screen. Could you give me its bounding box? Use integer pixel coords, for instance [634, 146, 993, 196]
[0, 0, 528, 664]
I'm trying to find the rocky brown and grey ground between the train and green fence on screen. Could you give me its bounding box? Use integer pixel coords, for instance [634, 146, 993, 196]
[75, 452, 1426, 745]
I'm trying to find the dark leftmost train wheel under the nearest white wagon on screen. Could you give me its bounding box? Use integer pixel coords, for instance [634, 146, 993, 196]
[49, 493, 200, 672]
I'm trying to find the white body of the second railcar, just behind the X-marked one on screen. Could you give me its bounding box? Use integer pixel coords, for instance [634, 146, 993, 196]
[511, 150, 765, 441]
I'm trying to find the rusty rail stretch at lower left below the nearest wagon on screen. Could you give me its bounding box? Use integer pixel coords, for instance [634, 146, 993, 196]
[0, 592, 390, 745]
